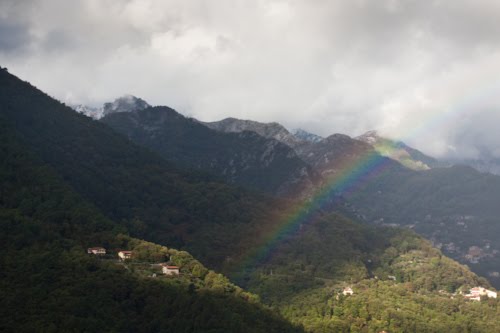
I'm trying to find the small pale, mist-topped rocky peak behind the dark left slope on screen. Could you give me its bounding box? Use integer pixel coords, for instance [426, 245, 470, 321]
[71, 95, 151, 119]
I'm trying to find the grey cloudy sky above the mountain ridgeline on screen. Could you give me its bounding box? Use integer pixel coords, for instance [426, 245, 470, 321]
[0, 0, 500, 158]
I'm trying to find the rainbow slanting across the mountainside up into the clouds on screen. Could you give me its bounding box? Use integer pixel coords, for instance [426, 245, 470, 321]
[233, 81, 496, 279]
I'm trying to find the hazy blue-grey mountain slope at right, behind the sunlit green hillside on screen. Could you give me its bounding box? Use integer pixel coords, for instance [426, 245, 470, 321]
[347, 162, 500, 287]
